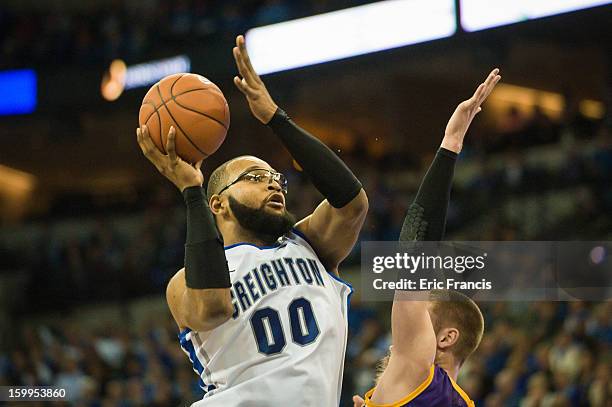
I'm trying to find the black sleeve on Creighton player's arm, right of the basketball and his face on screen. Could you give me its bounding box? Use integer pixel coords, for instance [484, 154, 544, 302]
[268, 108, 361, 208]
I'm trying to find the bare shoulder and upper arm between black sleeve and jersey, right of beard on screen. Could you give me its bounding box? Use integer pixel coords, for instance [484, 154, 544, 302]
[296, 189, 369, 272]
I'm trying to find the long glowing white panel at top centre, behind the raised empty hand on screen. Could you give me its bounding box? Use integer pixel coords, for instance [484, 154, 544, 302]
[246, 0, 457, 75]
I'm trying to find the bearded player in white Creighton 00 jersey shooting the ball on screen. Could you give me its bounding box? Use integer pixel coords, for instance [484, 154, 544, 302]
[137, 36, 368, 407]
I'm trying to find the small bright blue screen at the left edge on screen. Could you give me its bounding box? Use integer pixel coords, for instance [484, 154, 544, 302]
[0, 69, 37, 116]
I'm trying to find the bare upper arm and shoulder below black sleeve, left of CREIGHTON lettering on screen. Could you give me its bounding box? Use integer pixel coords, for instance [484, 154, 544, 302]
[166, 269, 233, 332]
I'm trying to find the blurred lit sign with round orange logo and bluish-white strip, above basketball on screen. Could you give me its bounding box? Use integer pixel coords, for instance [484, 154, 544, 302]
[100, 55, 191, 101]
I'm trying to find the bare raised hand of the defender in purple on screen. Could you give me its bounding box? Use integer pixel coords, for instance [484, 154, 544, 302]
[442, 68, 501, 153]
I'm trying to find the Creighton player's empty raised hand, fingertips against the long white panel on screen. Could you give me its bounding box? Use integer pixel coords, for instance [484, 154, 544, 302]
[232, 35, 278, 124]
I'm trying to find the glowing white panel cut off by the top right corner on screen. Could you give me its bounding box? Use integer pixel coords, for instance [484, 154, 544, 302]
[461, 0, 610, 31]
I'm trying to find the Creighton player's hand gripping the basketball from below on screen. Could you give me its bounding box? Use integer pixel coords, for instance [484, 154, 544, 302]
[136, 125, 204, 192]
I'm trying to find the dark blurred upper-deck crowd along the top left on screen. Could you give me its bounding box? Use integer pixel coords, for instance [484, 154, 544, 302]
[0, 0, 368, 66]
